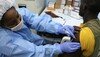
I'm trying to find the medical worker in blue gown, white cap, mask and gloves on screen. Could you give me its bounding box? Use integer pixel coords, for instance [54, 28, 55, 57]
[0, 0, 80, 57]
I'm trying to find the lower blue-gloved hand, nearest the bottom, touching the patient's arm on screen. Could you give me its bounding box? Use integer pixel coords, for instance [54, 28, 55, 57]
[60, 42, 80, 53]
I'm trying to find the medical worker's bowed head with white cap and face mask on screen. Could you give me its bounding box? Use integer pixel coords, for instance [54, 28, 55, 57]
[0, 0, 22, 30]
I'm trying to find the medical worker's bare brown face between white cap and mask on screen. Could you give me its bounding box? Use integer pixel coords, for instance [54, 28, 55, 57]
[1, 7, 21, 28]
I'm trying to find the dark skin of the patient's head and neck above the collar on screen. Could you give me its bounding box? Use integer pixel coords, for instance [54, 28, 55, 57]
[79, 0, 100, 23]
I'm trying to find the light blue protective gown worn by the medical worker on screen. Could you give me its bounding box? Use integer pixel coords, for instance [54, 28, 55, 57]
[0, 8, 62, 57]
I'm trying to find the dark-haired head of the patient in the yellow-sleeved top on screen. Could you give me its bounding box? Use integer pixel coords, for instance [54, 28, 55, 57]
[79, 0, 100, 18]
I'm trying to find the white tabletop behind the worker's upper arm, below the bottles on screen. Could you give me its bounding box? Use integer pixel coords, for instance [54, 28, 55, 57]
[41, 8, 83, 26]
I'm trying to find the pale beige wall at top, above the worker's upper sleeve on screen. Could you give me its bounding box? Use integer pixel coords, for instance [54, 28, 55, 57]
[16, 0, 45, 14]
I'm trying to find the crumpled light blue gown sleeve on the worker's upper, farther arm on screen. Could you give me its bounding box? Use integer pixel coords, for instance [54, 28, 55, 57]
[18, 8, 62, 34]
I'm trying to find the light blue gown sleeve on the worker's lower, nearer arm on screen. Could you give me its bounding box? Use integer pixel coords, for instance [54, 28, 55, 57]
[0, 31, 62, 57]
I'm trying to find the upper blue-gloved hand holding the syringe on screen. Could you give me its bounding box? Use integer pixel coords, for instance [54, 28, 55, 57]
[58, 25, 75, 38]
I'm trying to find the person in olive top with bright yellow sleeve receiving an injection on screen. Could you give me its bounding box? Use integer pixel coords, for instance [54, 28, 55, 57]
[79, 0, 100, 57]
